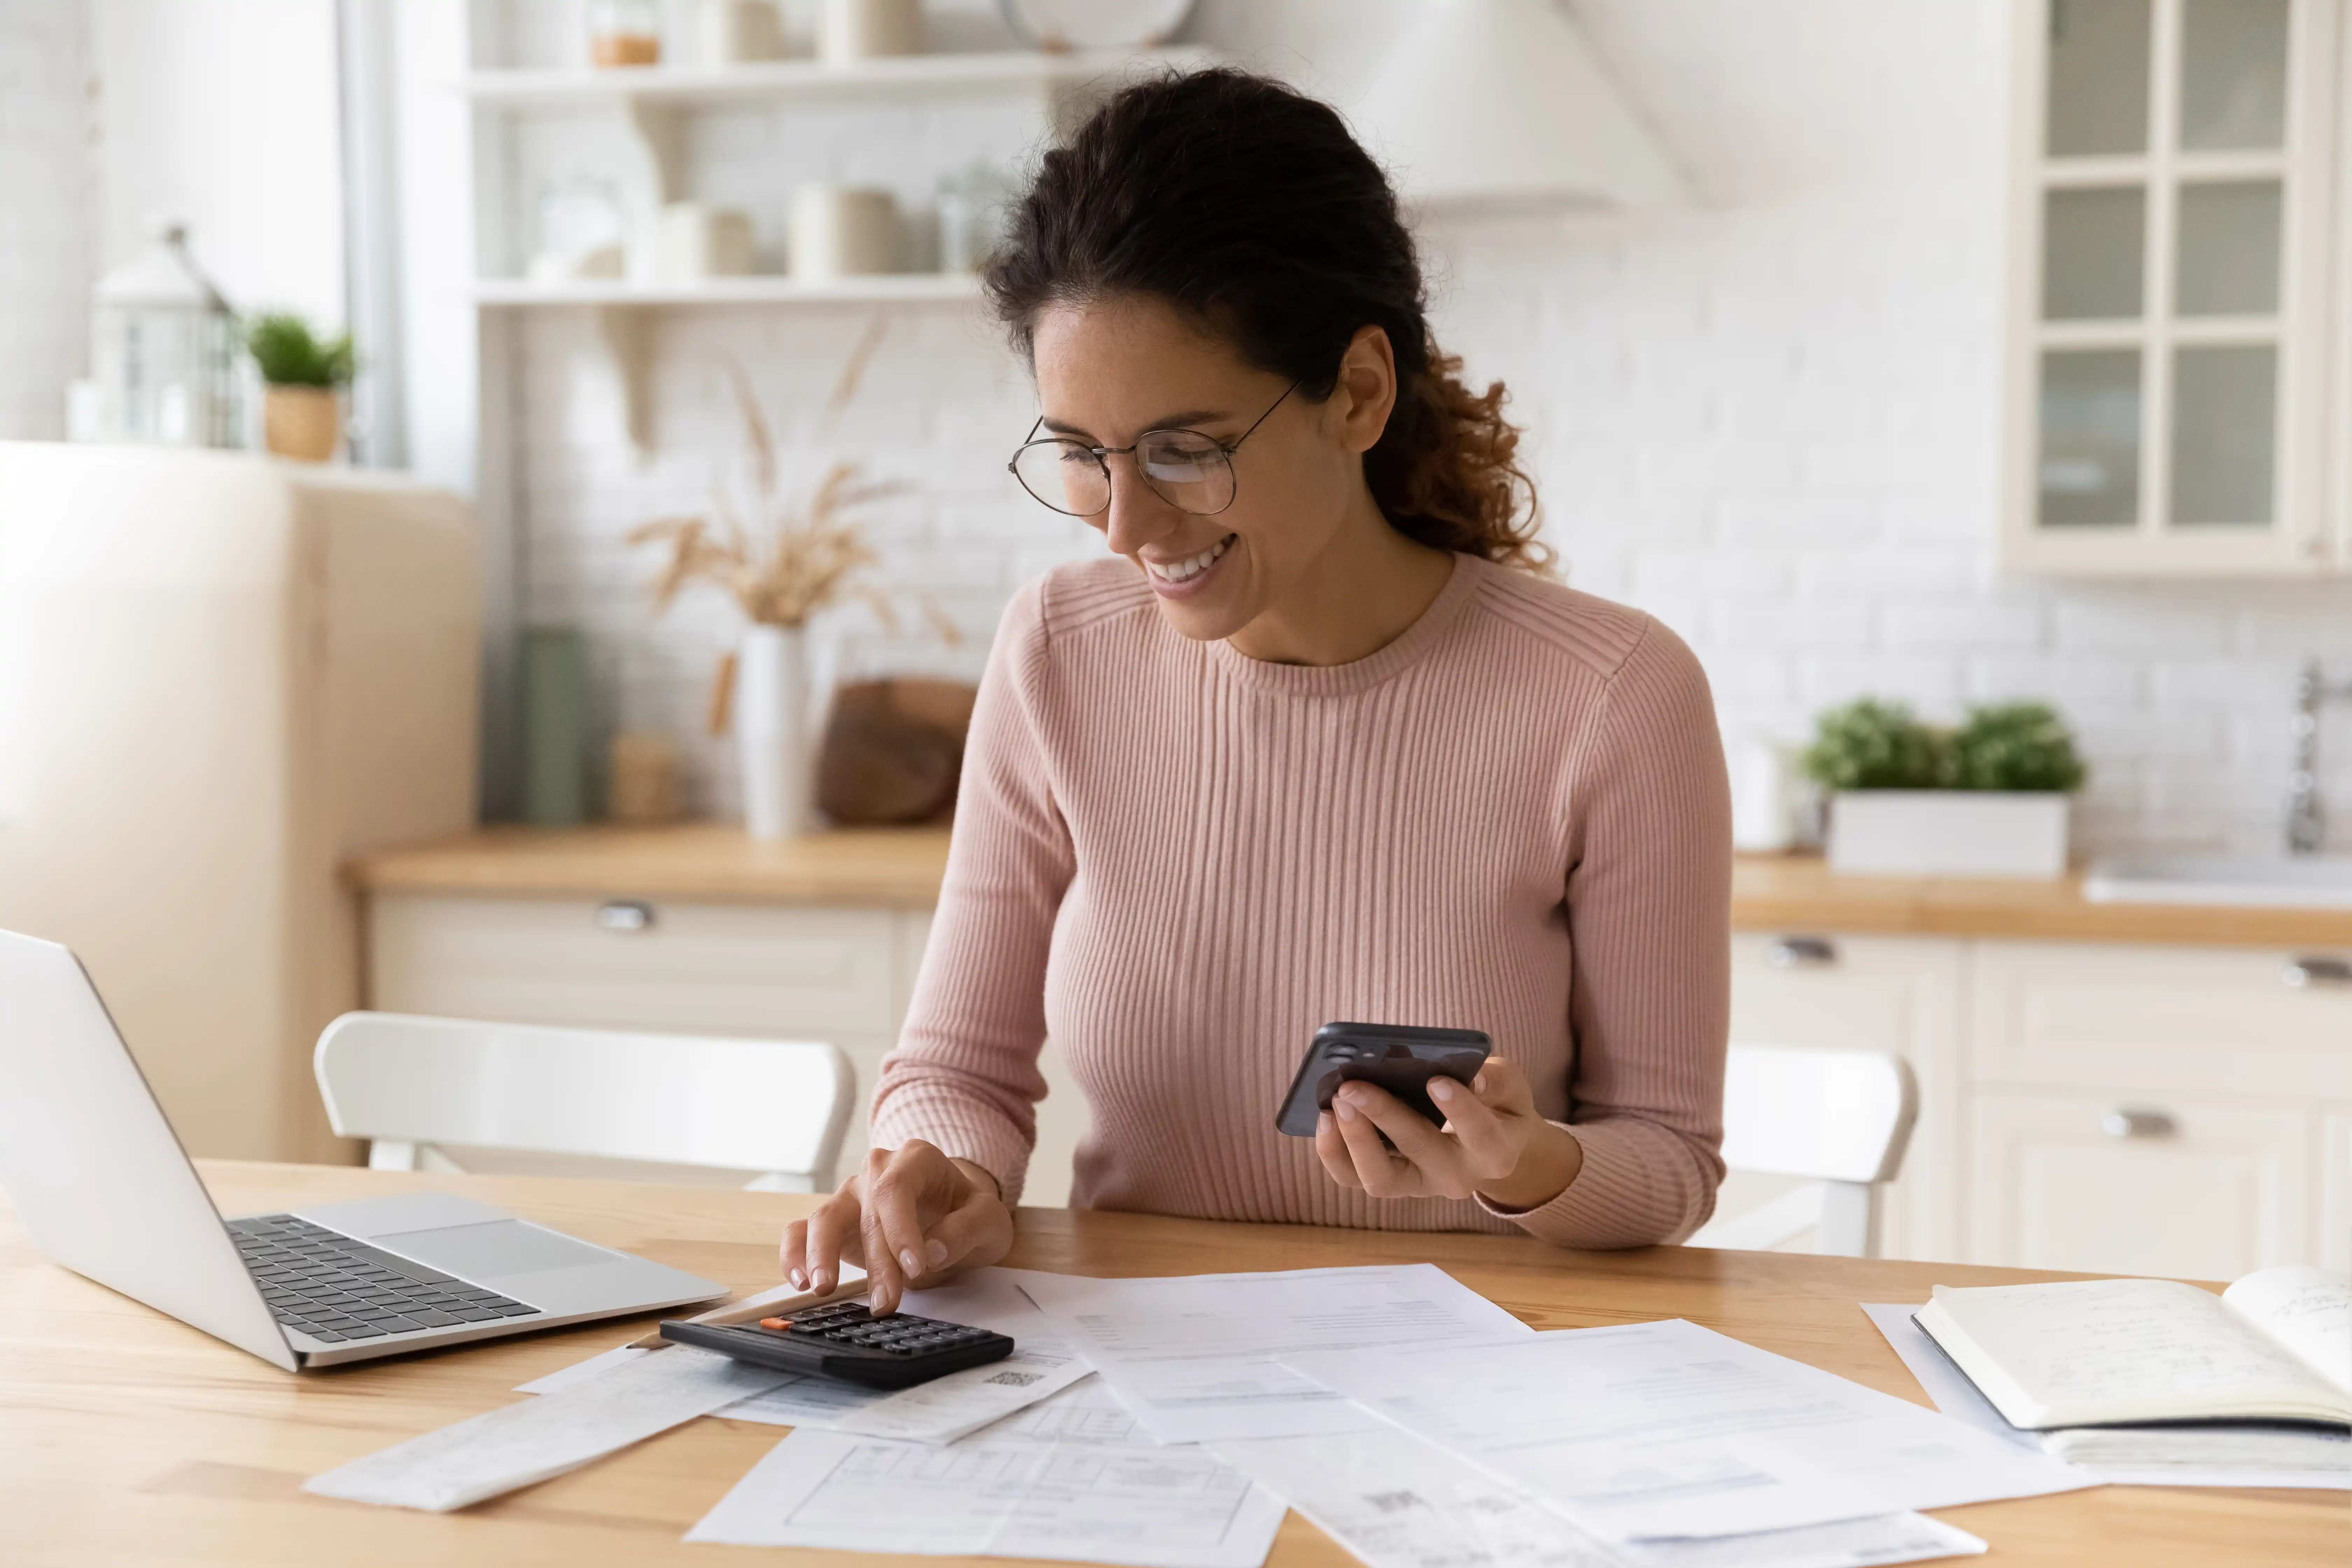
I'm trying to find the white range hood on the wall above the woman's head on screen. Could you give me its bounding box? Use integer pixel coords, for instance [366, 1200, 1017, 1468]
[1352, 0, 1689, 211]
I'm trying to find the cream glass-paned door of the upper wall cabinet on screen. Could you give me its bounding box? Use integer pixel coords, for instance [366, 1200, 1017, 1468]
[2002, 0, 2347, 576]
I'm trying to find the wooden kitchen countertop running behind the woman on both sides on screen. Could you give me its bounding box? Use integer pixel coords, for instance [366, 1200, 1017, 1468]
[350, 823, 2352, 947]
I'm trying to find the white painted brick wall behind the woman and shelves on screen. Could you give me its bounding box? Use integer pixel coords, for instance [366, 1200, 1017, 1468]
[501, 0, 2352, 853]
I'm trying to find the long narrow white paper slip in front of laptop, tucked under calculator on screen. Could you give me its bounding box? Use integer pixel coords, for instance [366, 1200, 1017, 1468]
[303, 1349, 790, 1512]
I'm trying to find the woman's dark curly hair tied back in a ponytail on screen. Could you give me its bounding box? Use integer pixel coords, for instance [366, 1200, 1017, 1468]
[988, 70, 1552, 574]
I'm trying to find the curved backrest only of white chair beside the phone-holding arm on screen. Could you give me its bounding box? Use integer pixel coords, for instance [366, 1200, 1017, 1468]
[1724, 1046, 1919, 1182]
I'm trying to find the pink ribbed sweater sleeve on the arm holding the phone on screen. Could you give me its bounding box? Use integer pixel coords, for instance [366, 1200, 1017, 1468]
[1482, 623, 1731, 1248]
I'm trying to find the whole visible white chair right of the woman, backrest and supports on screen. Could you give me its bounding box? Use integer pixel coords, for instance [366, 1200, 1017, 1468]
[1689, 1046, 1919, 1258]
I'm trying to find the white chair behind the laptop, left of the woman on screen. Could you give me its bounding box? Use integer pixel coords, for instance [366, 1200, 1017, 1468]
[313, 1013, 856, 1192]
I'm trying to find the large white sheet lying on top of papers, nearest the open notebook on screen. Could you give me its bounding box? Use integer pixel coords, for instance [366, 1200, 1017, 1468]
[1291, 1319, 2091, 1542]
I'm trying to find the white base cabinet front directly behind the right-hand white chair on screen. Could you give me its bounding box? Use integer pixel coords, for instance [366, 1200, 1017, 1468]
[1717, 933, 1966, 1258]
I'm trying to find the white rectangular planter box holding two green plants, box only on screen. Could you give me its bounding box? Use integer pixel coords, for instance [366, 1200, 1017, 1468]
[1830, 790, 2067, 877]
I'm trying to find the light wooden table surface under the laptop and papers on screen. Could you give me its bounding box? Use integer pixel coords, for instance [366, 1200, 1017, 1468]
[0, 1161, 2352, 1568]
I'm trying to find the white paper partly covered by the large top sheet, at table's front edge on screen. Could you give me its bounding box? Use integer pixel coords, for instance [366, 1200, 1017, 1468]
[1209, 1427, 1985, 1568]
